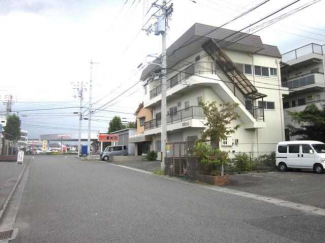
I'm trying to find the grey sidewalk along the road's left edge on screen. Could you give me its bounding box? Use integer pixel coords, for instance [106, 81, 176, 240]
[0, 162, 26, 214]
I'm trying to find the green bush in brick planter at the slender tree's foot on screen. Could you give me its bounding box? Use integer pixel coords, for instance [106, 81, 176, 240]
[194, 142, 229, 175]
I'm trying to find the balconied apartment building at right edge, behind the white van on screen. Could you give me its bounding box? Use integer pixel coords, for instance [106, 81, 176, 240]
[281, 43, 325, 140]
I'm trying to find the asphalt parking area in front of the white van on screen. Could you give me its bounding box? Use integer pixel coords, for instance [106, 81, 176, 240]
[225, 171, 325, 208]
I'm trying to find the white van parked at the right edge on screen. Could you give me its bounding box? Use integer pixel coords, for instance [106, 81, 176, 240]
[276, 140, 325, 174]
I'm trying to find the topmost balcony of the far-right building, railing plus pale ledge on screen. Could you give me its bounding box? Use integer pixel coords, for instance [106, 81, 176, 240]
[282, 43, 324, 65]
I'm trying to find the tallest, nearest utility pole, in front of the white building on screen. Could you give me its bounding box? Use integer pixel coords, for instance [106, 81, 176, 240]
[142, 0, 173, 171]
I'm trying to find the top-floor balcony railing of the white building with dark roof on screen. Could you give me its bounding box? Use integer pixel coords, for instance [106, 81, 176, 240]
[150, 62, 216, 99]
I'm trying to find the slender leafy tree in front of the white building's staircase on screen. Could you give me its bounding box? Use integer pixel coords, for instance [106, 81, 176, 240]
[202, 101, 239, 176]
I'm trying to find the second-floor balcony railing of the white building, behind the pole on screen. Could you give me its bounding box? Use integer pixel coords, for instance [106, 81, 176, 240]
[144, 106, 204, 130]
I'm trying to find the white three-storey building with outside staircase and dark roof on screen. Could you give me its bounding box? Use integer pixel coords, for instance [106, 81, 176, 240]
[141, 23, 289, 156]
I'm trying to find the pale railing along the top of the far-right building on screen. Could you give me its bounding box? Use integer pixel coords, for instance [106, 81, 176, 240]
[282, 43, 324, 62]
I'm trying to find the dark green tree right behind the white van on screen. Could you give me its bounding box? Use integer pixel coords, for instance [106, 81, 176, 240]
[287, 104, 325, 142]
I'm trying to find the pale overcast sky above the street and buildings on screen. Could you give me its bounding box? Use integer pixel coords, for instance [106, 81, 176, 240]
[0, 0, 325, 138]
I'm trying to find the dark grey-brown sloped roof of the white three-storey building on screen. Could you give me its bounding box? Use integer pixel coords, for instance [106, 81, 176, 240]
[141, 23, 281, 80]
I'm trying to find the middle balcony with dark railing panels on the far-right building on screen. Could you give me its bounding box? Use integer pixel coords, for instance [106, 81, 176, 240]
[282, 73, 325, 93]
